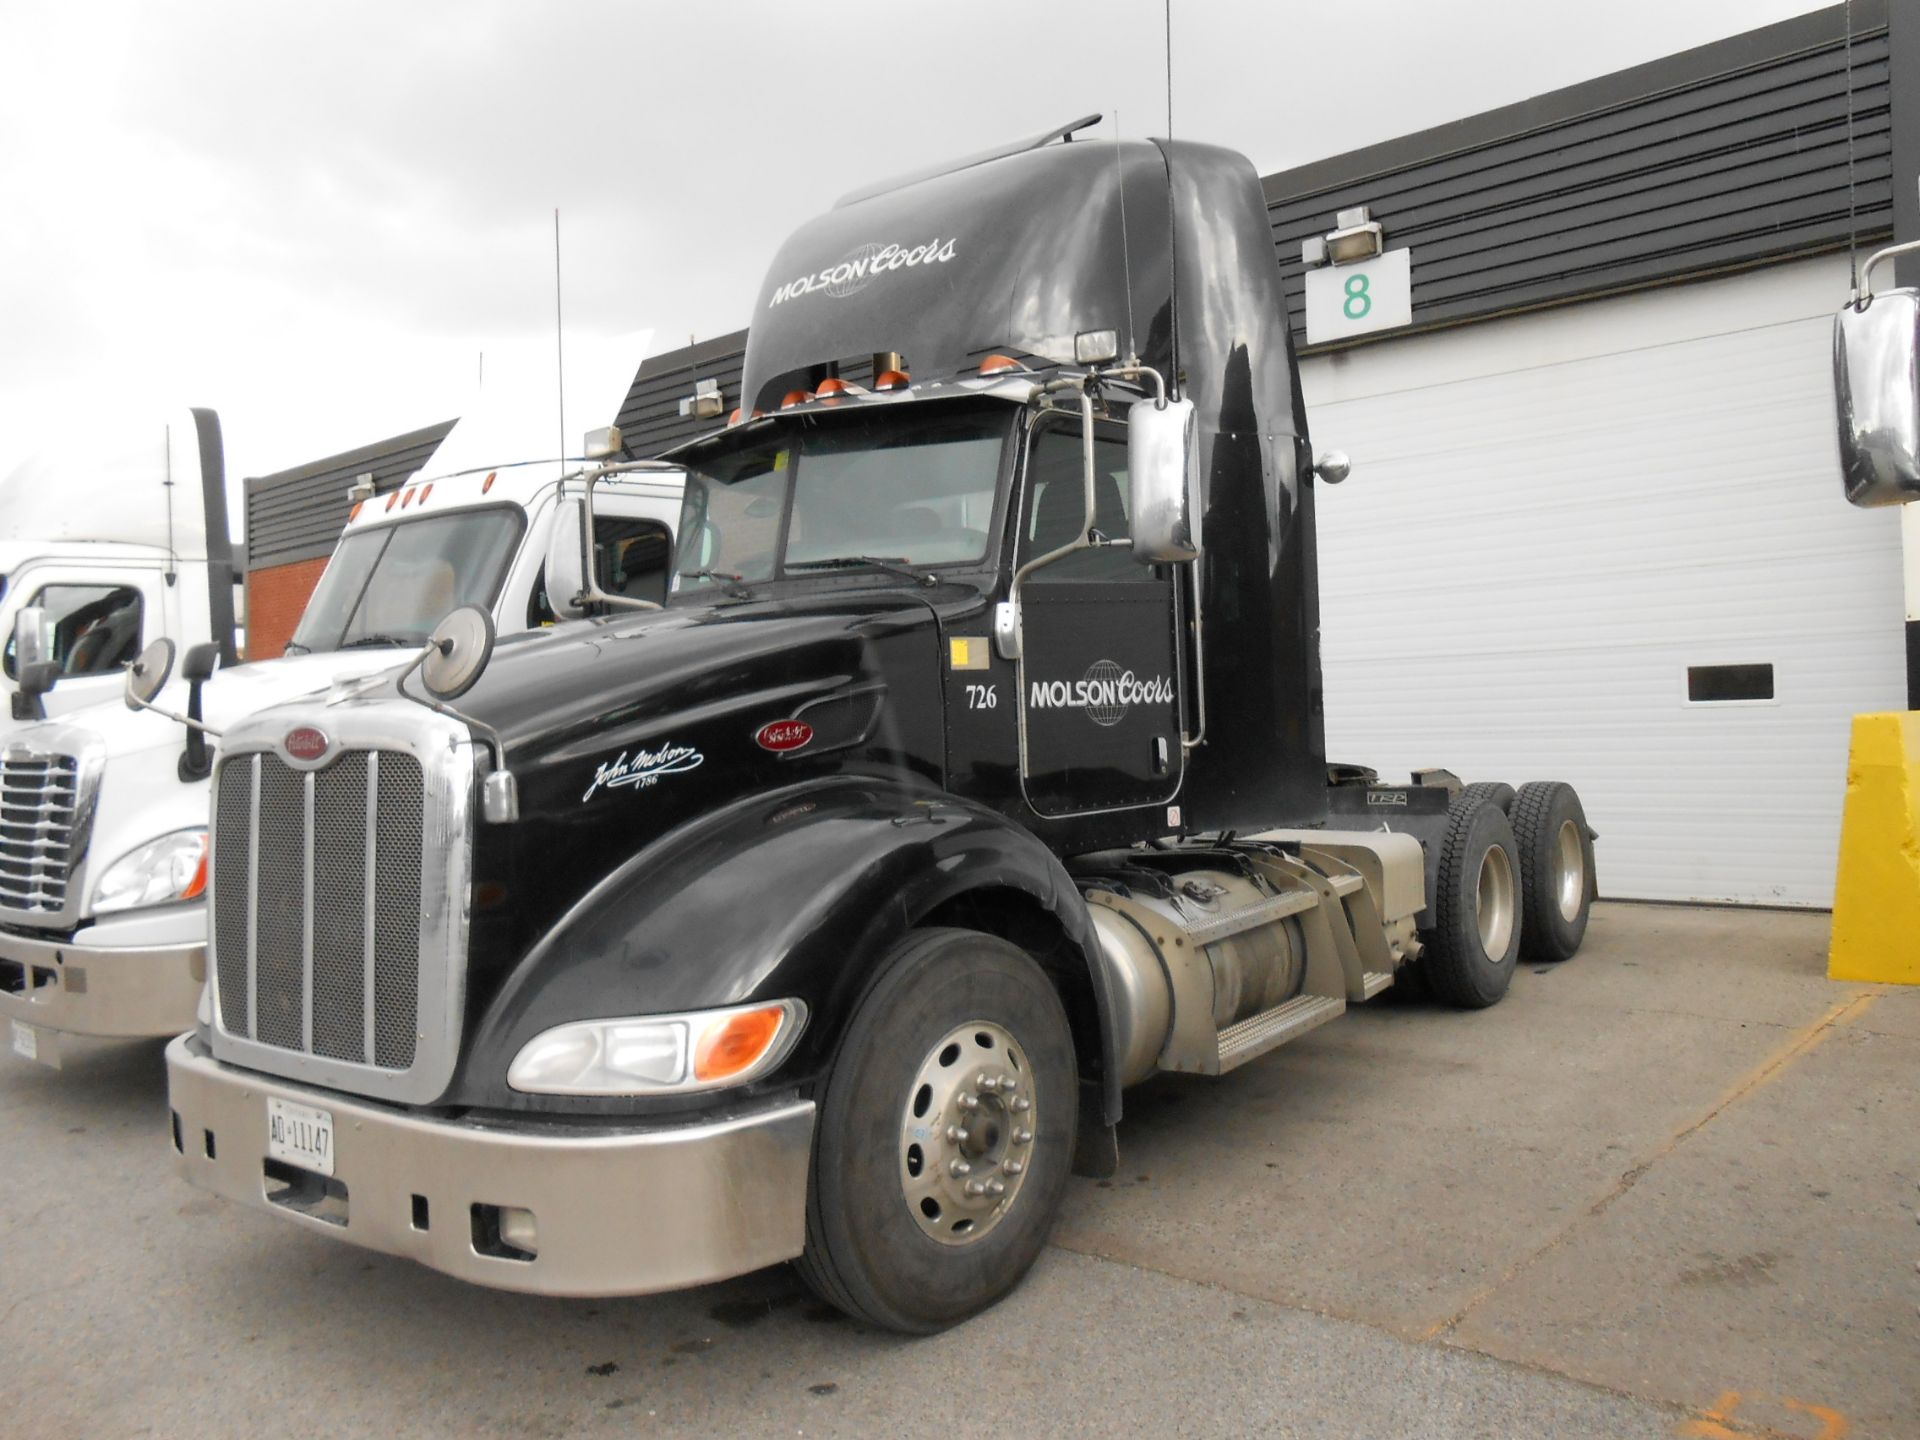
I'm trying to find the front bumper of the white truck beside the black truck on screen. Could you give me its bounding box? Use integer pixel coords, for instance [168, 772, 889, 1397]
[0, 929, 207, 1060]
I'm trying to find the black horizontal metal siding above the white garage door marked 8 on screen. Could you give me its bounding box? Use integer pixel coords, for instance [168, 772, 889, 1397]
[1265, 0, 1891, 346]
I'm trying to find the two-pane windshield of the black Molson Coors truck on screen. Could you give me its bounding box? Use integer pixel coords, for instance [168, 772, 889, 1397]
[674, 403, 1014, 591]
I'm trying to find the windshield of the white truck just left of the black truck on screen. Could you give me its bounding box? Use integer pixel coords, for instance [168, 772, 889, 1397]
[288, 505, 522, 653]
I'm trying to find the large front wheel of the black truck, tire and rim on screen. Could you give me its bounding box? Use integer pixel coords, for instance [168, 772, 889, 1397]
[799, 929, 1079, 1334]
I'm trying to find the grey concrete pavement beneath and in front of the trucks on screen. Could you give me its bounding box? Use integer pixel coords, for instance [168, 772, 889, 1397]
[0, 904, 1920, 1440]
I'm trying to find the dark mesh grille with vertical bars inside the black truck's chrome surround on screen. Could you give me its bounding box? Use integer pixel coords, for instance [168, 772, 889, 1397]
[211, 749, 436, 1071]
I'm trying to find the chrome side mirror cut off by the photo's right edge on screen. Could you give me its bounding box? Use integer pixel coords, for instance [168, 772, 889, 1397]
[1834, 290, 1920, 505]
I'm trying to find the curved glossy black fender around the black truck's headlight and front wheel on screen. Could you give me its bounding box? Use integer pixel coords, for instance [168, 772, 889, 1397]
[447, 778, 1119, 1123]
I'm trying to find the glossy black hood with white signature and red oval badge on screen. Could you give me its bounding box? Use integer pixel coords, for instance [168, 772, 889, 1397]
[451, 586, 960, 1029]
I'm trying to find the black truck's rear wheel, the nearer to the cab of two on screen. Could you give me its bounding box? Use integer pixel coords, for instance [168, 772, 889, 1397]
[1421, 795, 1521, 1010]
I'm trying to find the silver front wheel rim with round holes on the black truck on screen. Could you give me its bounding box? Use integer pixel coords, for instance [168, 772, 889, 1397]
[900, 1020, 1037, 1246]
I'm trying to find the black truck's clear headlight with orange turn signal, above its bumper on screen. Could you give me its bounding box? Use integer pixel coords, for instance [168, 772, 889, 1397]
[507, 1000, 806, 1094]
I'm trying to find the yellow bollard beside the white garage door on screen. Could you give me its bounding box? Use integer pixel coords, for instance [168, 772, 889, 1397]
[1826, 710, 1920, 985]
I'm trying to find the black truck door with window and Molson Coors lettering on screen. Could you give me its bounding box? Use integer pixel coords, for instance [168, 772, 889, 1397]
[1018, 417, 1185, 816]
